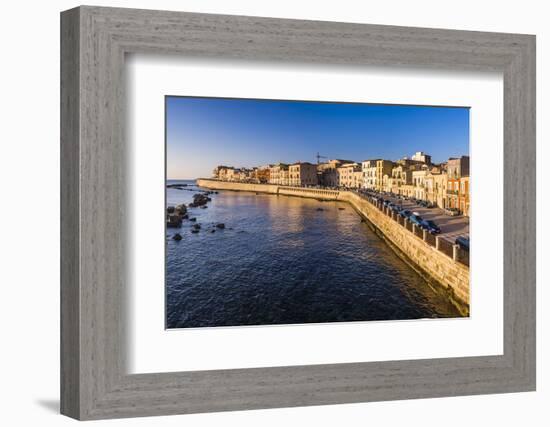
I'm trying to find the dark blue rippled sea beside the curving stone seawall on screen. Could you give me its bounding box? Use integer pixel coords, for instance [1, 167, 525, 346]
[166, 181, 460, 328]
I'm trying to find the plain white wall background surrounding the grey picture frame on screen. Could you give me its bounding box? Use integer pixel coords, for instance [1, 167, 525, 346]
[0, 0, 550, 427]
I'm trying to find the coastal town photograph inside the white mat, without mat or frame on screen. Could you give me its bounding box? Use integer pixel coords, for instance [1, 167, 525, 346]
[165, 96, 470, 328]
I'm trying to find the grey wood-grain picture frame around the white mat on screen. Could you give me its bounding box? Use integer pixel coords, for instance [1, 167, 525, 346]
[61, 6, 535, 420]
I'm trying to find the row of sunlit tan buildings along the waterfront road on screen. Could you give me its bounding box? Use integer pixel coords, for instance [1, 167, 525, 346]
[213, 151, 470, 216]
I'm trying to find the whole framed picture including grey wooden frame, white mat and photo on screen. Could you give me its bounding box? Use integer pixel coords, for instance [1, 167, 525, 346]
[61, 6, 535, 419]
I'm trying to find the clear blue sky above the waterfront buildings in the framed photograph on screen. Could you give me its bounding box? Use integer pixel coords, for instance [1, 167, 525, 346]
[166, 97, 470, 179]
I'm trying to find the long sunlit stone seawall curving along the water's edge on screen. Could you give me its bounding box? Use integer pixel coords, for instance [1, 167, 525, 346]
[197, 179, 470, 314]
